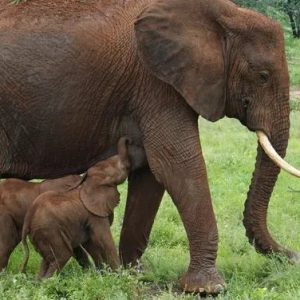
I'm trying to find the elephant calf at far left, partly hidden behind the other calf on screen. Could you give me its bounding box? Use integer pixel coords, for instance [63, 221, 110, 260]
[0, 176, 84, 271]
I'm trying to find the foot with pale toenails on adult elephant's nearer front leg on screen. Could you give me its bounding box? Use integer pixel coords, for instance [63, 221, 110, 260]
[180, 268, 226, 295]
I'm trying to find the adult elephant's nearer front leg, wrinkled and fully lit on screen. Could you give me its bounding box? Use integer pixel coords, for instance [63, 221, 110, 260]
[144, 116, 225, 293]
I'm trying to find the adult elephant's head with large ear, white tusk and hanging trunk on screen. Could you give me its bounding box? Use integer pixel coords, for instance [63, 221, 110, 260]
[135, 0, 300, 256]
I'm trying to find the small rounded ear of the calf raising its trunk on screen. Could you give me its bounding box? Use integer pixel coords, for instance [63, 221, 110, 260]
[80, 176, 120, 217]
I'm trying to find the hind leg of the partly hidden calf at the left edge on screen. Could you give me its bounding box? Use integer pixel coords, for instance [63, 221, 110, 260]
[0, 214, 20, 271]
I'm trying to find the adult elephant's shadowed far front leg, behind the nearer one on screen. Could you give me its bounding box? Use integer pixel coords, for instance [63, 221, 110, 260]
[119, 168, 164, 265]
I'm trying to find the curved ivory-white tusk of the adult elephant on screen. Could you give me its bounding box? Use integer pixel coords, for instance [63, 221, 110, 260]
[256, 131, 300, 178]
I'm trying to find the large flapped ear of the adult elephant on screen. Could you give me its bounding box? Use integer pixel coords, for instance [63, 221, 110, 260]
[135, 0, 233, 121]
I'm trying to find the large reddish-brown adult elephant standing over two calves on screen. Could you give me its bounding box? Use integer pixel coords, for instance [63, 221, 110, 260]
[0, 0, 298, 293]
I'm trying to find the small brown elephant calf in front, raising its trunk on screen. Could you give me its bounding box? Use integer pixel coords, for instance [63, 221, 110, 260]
[22, 138, 129, 278]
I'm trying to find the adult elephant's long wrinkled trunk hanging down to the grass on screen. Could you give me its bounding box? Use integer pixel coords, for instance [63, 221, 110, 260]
[243, 99, 296, 260]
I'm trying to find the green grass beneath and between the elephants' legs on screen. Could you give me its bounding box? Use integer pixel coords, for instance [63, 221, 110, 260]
[0, 112, 300, 300]
